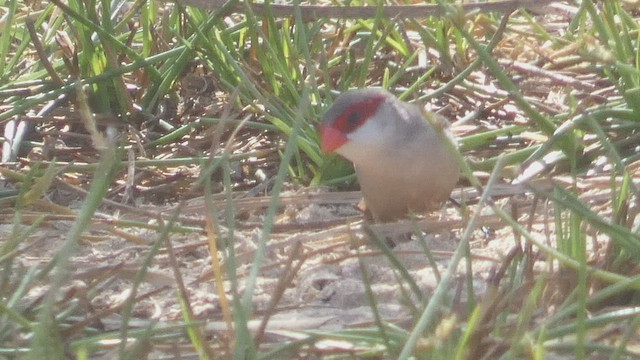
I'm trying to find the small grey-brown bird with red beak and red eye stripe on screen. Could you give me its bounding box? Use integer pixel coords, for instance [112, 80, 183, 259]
[320, 89, 459, 221]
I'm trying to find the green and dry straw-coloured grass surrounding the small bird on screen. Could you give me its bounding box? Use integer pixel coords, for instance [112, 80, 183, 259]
[0, 0, 640, 359]
